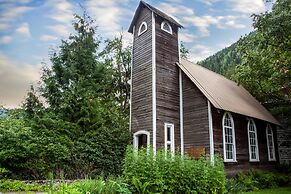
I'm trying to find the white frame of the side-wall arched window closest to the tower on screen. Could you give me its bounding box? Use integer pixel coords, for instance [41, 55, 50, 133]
[222, 112, 237, 162]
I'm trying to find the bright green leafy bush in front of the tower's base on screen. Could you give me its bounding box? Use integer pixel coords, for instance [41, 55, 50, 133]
[123, 147, 226, 193]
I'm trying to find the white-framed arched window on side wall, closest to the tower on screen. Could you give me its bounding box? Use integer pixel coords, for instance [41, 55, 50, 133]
[222, 112, 236, 162]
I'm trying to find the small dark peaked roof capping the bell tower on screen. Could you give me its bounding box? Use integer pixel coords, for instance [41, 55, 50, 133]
[128, 1, 183, 33]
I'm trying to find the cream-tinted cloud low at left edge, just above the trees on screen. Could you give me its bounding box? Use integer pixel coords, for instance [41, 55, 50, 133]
[0, 52, 41, 108]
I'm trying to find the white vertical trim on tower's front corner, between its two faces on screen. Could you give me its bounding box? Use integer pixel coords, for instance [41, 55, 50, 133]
[152, 12, 157, 154]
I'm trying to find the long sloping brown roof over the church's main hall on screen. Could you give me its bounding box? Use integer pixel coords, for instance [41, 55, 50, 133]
[177, 59, 281, 125]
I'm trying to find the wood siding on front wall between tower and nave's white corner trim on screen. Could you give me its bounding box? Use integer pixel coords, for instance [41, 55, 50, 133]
[182, 73, 209, 154]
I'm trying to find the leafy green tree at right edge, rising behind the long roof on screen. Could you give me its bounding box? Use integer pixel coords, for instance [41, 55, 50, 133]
[231, 0, 291, 121]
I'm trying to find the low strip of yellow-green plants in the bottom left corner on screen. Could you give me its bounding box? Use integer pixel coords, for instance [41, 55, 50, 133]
[0, 179, 47, 192]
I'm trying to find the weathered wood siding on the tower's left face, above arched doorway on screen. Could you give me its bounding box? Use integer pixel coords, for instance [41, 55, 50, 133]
[131, 5, 153, 143]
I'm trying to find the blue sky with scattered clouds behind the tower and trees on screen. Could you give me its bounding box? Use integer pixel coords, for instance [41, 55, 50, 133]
[0, 0, 271, 108]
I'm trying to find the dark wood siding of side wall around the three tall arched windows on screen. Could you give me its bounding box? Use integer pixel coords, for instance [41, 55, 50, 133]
[212, 106, 279, 176]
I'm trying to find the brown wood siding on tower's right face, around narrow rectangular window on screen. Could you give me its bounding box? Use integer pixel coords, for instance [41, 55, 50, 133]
[155, 16, 181, 150]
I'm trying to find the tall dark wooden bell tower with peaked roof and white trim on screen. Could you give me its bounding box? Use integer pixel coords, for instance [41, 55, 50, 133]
[128, 1, 182, 151]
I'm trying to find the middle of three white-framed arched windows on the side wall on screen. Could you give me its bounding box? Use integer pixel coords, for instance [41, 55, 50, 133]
[248, 119, 259, 161]
